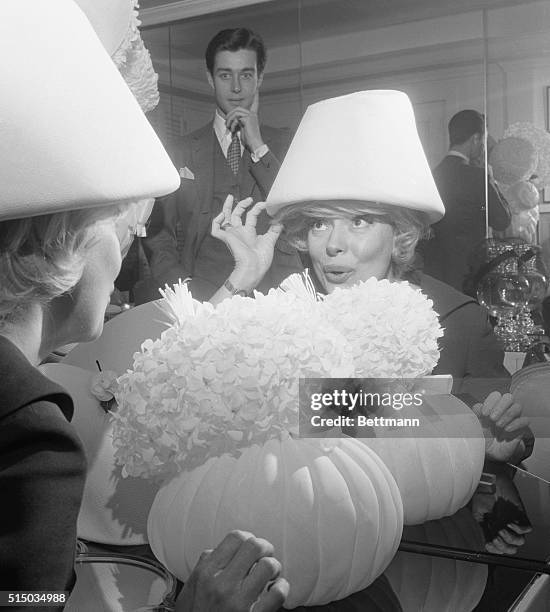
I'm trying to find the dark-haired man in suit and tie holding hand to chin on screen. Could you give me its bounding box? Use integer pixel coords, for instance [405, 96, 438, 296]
[144, 28, 302, 300]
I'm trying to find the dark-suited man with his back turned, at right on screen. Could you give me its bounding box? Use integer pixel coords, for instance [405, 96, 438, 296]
[420, 110, 511, 291]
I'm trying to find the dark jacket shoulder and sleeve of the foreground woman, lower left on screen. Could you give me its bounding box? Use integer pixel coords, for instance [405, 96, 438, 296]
[0, 402, 86, 610]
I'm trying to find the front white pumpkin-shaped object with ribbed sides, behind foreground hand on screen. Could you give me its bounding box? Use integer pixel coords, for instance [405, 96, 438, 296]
[148, 433, 402, 608]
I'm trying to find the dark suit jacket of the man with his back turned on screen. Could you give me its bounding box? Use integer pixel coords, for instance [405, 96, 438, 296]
[420, 155, 511, 291]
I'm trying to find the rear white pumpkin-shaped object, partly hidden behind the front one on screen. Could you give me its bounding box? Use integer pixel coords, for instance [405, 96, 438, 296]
[360, 395, 485, 525]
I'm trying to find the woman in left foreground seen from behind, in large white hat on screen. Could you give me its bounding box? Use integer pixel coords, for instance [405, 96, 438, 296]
[0, 0, 288, 611]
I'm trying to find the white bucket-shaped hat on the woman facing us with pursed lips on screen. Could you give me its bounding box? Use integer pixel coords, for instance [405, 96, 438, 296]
[267, 90, 445, 223]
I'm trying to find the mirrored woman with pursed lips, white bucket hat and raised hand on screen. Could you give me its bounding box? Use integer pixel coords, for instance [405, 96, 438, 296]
[212, 90, 532, 459]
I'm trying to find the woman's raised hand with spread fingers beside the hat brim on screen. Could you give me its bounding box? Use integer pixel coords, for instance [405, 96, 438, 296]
[211, 195, 283, 291]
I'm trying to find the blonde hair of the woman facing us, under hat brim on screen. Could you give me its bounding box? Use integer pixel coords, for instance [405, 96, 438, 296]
[273, 200, 429, 278]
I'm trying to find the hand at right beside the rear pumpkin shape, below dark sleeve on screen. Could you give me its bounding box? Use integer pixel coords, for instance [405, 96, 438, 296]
[472, 391, 529, 461]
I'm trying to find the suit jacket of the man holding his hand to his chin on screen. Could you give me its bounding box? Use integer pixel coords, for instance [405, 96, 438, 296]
[144, 123, 302, 299]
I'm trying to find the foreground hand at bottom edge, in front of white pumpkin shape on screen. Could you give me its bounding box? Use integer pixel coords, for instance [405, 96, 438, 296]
[176, 531, 289, 612]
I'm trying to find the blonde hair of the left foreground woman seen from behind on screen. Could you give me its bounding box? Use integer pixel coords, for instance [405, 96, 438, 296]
[0, 202, 132, 327]
